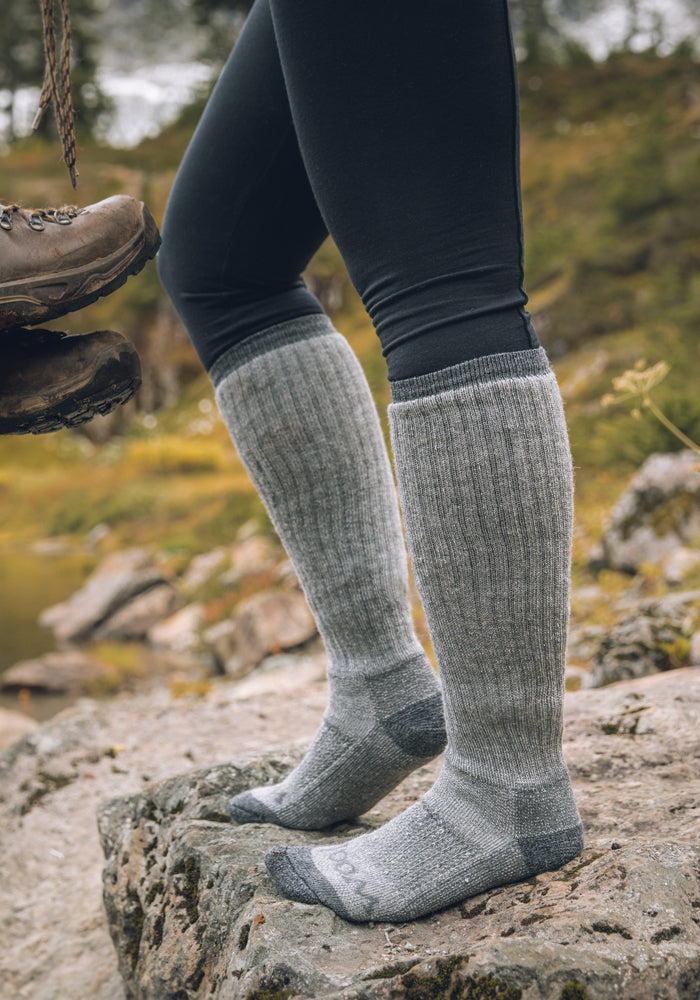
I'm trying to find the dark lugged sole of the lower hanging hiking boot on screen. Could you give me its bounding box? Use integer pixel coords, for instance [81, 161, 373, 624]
[0, 345, 141, 434]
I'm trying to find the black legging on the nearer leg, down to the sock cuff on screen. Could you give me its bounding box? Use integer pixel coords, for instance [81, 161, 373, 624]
[270, 0, 538, 380]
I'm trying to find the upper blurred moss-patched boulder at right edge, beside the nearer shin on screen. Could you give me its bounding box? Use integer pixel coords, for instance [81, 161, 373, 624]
[593, 450, 700, 581]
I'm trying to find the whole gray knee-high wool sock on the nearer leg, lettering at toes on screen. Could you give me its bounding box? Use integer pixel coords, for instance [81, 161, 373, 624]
[266, 348, 583, 921]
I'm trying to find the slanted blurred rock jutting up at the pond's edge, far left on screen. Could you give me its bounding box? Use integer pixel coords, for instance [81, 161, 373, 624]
[39, 549, 166, 642]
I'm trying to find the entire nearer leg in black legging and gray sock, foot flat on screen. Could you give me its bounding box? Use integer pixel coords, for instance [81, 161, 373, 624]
[266, 0, 582, 921]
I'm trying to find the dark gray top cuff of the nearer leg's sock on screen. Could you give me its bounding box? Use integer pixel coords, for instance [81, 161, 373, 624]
[389, 347, 551, 403]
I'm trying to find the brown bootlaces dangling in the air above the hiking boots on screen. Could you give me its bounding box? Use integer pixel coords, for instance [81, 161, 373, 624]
[32, 0, 78, 187]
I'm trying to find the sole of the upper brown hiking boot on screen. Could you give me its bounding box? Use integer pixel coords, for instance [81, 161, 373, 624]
[0, 205, 161, 332]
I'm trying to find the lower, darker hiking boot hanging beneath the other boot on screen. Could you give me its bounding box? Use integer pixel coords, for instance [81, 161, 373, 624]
[0, 330, 141, 434]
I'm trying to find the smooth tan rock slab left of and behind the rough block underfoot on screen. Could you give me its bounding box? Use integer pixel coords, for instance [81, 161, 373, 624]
[0, 656, 325, 1000]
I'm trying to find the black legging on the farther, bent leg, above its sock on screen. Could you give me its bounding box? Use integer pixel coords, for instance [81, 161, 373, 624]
[158, 0, 328, 371]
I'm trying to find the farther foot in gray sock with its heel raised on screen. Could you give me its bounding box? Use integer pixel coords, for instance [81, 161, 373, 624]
[229, 657, 446, 830]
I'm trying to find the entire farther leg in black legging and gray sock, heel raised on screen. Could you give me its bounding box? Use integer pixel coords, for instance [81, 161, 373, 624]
[160, 0, 445, 829]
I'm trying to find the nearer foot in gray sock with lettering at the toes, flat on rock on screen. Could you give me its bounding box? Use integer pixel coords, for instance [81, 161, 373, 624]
[265, 762, 583, 922]
